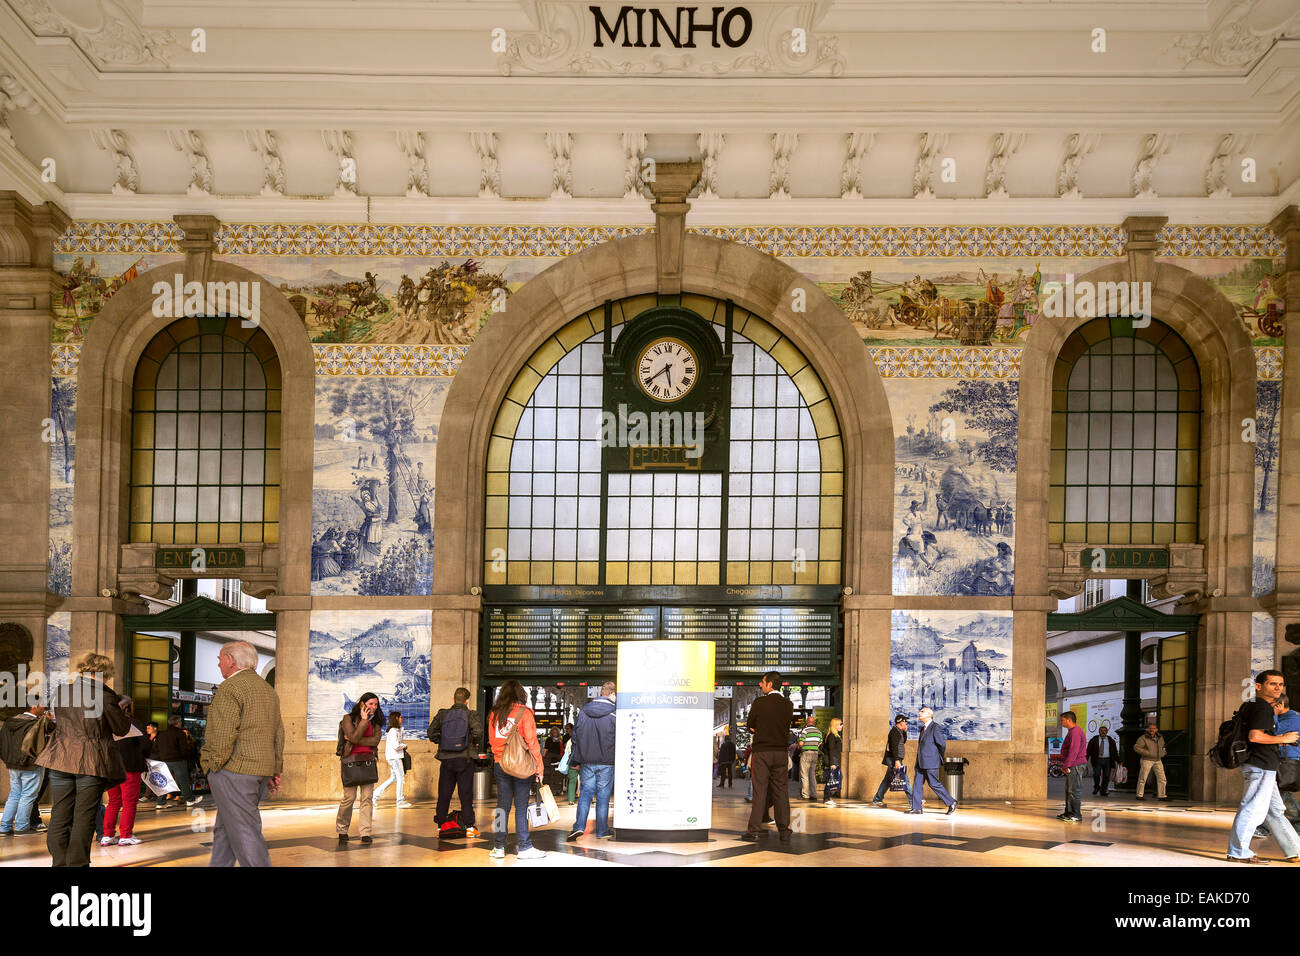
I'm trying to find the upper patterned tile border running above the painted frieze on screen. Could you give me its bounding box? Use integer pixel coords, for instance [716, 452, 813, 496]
[55, 220, 1282, 259]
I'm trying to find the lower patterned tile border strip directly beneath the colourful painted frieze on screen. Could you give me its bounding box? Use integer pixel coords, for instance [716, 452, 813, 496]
[49, 342, 1282, 381]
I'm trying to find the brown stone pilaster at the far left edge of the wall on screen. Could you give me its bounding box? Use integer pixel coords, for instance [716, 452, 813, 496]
[0, 191, 70, 681]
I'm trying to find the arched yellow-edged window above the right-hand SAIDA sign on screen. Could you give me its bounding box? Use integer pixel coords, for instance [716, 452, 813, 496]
[1048, 319, 1201, 545]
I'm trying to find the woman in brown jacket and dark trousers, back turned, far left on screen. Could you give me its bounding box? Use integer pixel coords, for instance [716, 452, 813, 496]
[36, 653, 131, 866]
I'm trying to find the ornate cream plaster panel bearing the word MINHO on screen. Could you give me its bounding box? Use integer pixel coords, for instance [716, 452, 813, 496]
[497, 0, 845, 77]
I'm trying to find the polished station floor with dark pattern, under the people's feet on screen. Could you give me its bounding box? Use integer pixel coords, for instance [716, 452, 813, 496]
[0, 788, 1292, 870]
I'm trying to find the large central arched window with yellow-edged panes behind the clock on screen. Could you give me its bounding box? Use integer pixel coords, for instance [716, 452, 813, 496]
[484, 295, 844, 585]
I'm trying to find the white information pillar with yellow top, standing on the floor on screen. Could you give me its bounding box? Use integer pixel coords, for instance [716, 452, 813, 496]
[614, 640, 716, 843]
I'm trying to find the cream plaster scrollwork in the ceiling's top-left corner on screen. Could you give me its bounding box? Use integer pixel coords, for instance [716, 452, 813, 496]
[9, 0, 182, 69]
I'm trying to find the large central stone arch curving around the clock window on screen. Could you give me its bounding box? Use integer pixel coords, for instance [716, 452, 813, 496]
[433, 234, 893, 596]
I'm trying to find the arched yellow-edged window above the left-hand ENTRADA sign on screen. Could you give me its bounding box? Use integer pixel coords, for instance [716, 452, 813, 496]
[130, 317, 281, 545]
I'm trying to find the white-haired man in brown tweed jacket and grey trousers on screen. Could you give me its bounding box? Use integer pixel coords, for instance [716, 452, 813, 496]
[200, 641, 285, 866]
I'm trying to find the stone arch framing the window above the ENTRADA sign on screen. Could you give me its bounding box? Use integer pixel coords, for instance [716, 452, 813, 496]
[73, 257, 315, 652]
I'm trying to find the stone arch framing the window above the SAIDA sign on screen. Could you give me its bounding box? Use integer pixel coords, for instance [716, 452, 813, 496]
[1015, 260, 1256, 801]
